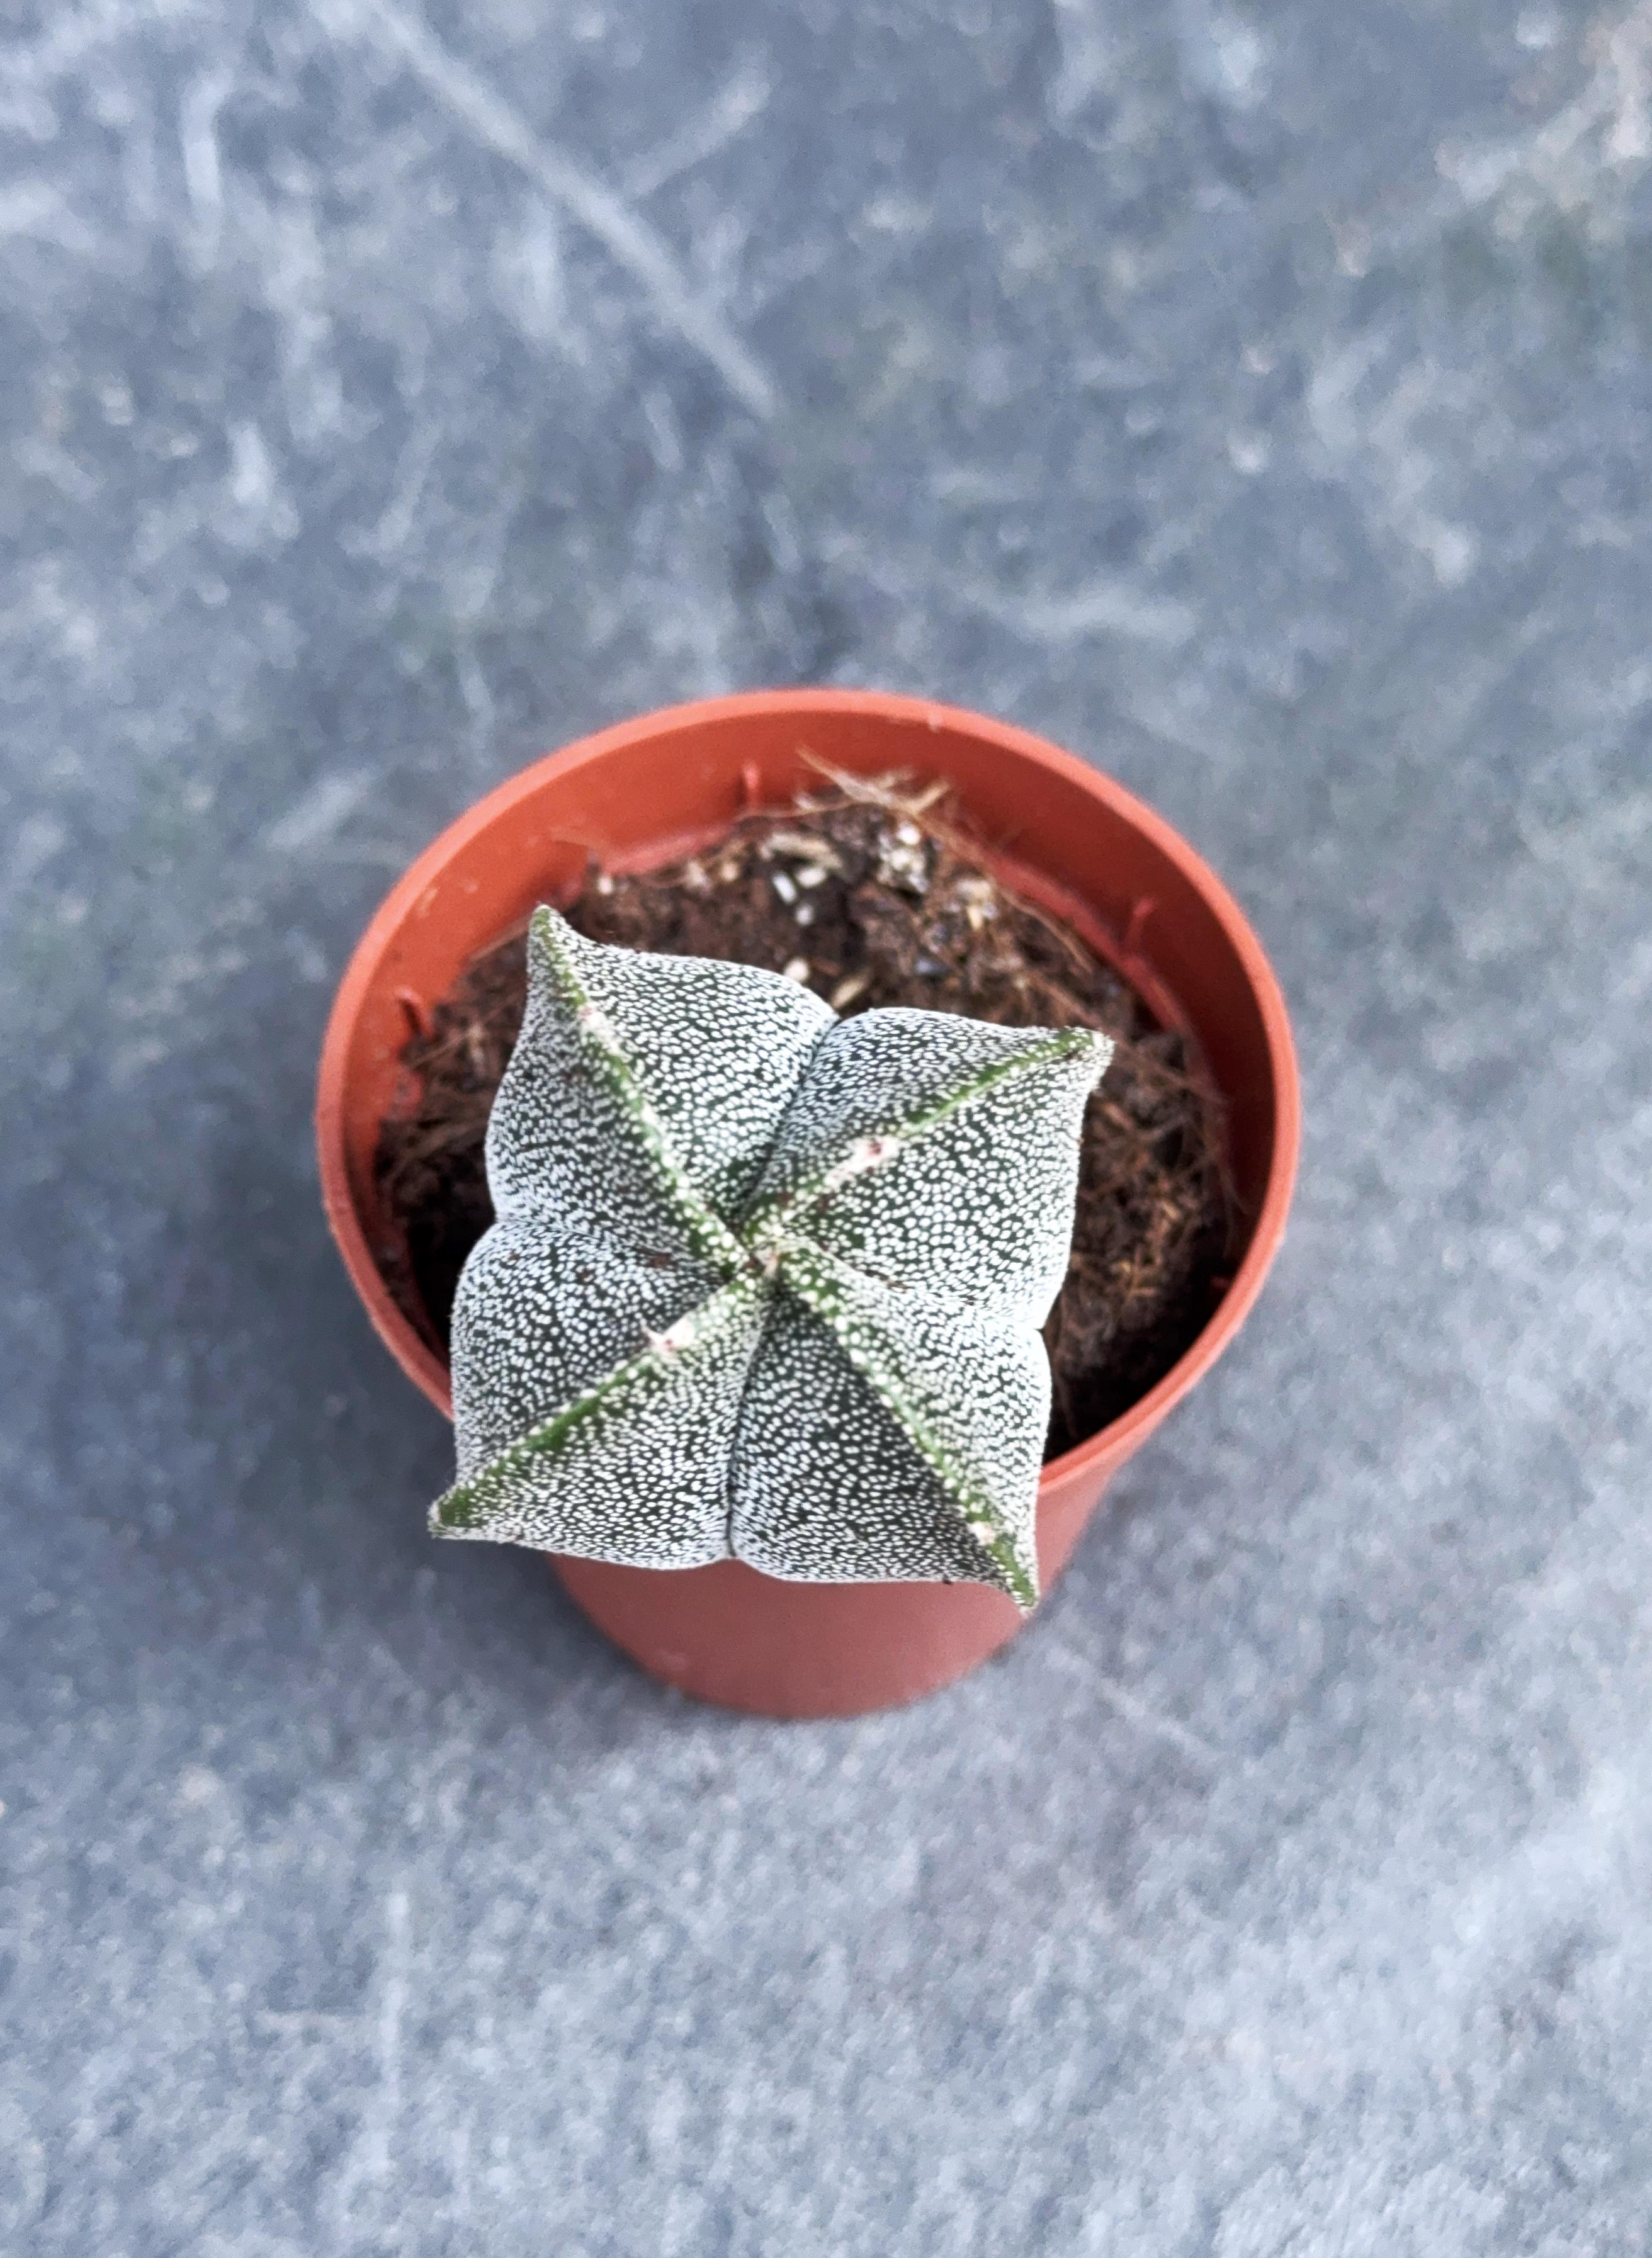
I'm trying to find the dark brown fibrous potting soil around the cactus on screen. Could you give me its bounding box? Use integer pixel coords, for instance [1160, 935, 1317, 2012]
[377, 777, 1235, 1457]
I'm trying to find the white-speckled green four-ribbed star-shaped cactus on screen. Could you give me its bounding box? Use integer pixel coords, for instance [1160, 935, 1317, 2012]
[431, 908, 1112, 1608]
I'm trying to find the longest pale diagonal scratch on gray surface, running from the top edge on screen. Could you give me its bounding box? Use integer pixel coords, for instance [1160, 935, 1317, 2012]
[338, 0, 779, 420]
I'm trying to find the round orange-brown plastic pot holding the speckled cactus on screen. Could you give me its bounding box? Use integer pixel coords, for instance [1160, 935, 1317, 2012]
[316, 691, 1300, 1716]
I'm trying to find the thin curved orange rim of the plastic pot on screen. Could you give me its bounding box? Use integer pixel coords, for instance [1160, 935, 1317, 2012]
[316, 689, 1302, 1490]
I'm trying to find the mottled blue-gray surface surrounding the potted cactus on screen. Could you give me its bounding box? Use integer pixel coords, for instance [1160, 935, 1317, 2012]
[0, 0, 1652, 2258]
